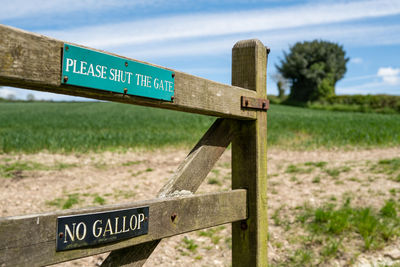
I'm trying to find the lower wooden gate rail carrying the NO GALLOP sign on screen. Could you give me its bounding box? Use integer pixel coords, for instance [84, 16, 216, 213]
[0, 190, 247, 266]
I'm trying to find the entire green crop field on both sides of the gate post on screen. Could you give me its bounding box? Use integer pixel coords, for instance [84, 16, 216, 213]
[0, 102, 400, 153]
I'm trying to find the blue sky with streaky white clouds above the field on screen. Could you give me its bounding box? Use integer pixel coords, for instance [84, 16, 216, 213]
[0, 0, 400, 101]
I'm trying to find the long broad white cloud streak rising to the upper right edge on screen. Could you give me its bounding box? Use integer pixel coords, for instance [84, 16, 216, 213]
[44, 0, 400, 49]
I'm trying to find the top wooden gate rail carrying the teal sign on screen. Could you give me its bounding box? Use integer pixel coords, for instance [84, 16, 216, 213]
[0, 25, 256, 119]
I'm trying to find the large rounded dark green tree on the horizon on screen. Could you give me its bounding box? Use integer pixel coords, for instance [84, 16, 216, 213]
[275, 40, 349, 102]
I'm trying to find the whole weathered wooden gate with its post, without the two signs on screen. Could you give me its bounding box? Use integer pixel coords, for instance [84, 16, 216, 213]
[0, 25, 269, 266]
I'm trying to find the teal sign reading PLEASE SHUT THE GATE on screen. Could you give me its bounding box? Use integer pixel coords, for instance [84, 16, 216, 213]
[61, 44, 175, 101]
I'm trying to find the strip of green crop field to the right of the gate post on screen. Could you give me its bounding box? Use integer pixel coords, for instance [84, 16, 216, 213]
[268, 105, 400, 149]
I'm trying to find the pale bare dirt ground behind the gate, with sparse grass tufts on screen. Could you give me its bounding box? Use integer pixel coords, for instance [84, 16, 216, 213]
[0, 147, 400, 266]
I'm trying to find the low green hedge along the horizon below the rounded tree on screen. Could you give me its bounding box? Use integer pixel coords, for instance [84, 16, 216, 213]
[268, 95, 400, 114]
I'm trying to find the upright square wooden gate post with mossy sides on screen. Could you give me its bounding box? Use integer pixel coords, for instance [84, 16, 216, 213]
[232, 40, 268, 267]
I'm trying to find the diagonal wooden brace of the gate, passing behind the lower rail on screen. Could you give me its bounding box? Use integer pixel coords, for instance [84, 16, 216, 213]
[102, 119, 232, 267]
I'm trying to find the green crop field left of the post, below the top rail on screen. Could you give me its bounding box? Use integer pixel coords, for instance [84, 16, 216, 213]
[0, 102, 215, 153]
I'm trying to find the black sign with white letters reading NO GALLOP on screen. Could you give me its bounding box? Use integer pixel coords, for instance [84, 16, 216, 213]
[56, 207, 149, 251]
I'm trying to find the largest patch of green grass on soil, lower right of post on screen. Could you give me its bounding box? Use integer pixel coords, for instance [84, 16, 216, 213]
[272, 198, 400, 266]
